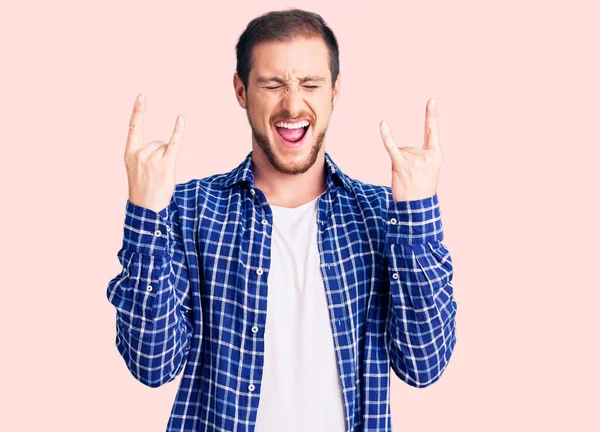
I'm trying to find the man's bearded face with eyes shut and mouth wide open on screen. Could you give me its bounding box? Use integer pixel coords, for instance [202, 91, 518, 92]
[234, 38, 341, 174]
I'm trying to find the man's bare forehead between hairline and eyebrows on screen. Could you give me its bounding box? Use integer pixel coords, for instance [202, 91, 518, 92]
[250, 38, 329, 79]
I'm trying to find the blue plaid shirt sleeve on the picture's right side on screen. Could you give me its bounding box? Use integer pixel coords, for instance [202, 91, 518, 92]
[385, 194, 457, 387]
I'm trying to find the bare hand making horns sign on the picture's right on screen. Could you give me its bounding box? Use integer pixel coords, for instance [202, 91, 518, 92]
[379, 98, 442, 202]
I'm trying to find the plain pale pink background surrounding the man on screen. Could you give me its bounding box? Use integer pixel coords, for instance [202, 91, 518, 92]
[0, 0, 600, 432]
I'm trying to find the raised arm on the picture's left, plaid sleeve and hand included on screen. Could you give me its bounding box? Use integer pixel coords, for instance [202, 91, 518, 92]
[106, 97, 195, 387]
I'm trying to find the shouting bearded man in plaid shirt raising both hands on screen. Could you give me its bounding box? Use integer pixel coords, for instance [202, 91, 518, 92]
[107, 9, 457, 432]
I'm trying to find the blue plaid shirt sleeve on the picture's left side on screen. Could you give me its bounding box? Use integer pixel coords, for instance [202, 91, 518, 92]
[106, 194, 193, 387]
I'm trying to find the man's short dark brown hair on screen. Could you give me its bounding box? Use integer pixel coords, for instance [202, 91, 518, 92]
[235, 8, 340, 90]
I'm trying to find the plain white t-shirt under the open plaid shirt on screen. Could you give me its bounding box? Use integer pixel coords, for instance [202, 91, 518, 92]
[256, 198, 346, 432]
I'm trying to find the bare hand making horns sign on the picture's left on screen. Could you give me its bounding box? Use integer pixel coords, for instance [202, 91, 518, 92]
[125, 94, 183, 212]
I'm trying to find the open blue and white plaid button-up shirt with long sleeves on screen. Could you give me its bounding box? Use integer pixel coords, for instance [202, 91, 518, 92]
[106, 152, 457, 432]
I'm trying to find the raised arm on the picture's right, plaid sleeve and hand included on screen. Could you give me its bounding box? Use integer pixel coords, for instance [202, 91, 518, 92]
[380, 99, 457, 387]
